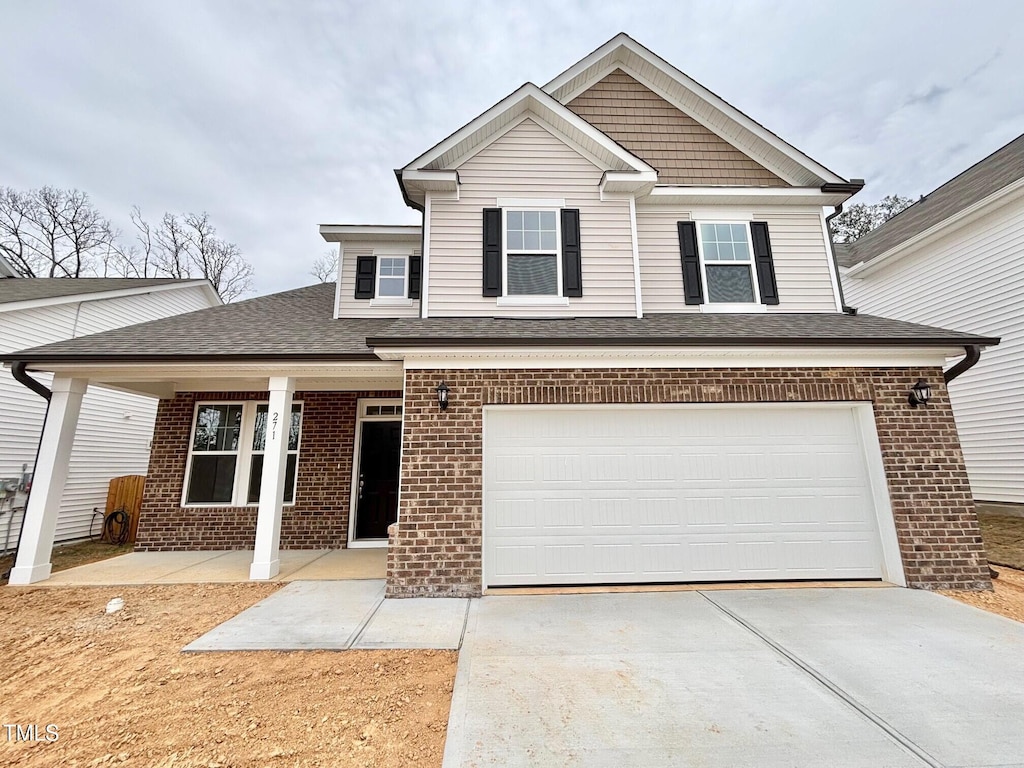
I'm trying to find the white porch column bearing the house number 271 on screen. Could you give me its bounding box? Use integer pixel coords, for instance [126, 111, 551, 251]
[249, 376, 295, 580]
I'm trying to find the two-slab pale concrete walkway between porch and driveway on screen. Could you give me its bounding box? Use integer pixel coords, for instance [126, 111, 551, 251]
[183, 580, 469, 651]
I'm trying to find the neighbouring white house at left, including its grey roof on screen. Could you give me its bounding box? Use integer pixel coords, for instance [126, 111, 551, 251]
[0, 280, 221, 547]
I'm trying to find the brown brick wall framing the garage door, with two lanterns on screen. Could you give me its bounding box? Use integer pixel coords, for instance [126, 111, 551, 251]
[388, 368, 991, 596]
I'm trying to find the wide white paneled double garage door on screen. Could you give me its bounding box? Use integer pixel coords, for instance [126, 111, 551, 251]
[483, 404, 883, 587]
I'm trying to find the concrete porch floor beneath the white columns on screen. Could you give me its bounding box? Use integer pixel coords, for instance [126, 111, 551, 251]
[33, 548, 387, 587]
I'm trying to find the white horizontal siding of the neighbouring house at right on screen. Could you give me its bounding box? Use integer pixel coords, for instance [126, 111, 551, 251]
[843, 200, 1024, 504]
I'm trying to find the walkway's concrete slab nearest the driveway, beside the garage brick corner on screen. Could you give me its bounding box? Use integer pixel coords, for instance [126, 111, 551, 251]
[352, 597, 469, 650]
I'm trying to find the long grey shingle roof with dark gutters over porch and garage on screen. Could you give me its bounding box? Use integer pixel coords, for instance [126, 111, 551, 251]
[0, 284, 997, 362]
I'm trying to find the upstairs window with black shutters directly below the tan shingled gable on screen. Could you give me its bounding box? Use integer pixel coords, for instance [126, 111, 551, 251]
[678, 221, 779, 312]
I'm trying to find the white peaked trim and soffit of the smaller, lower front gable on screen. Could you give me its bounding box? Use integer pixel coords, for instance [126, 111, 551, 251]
[401, 83, 654, 179]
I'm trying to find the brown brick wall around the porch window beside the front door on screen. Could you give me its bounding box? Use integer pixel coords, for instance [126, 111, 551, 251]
[135, 392, 401, 551]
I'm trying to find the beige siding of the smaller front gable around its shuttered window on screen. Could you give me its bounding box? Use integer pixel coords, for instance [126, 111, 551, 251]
[428, 119, 636, 317]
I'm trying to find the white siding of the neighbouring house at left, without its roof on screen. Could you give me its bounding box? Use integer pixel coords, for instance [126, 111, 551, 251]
[0, 287, 222, 546]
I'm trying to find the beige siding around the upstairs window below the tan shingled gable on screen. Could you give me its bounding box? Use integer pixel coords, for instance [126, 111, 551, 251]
[637, 206, 836, 314]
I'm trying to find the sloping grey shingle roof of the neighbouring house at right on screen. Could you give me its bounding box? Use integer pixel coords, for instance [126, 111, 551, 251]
[836, 134, 1024, 266]
